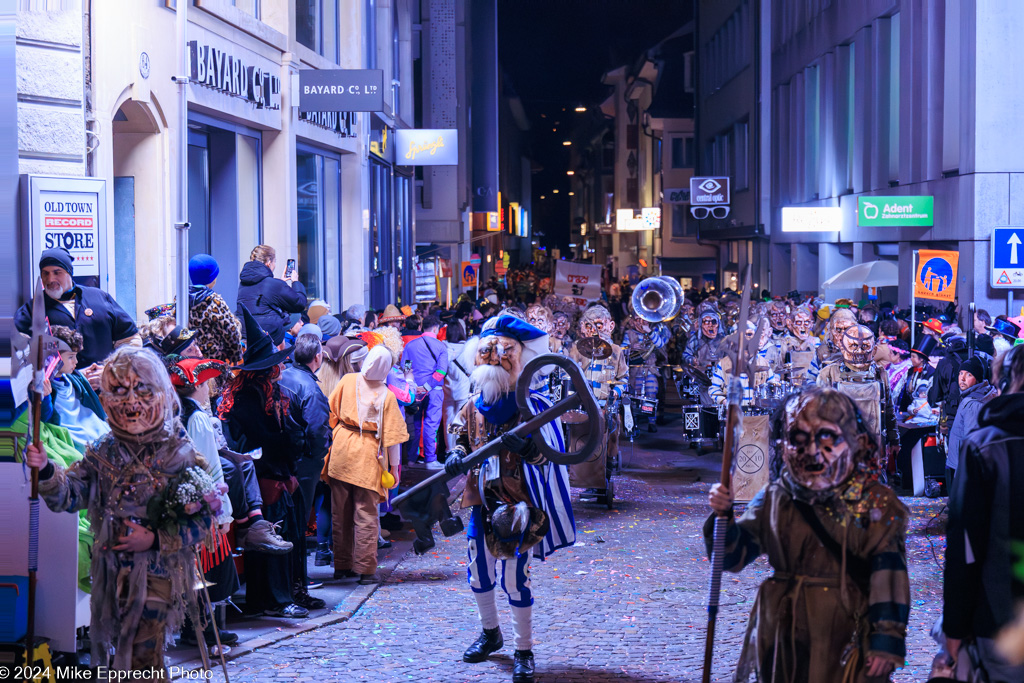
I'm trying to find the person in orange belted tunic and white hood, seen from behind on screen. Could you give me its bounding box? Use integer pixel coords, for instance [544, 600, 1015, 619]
[321, 344, 409, 585]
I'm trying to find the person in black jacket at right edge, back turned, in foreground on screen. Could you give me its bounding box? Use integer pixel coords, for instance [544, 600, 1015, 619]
[942, 348, 1024, 681]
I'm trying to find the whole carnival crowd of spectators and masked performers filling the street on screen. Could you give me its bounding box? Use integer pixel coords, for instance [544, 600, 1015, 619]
[16, 245, 1024, 683]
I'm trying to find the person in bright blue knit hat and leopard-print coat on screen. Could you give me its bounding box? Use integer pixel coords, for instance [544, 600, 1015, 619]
[188, 254, 242, 365]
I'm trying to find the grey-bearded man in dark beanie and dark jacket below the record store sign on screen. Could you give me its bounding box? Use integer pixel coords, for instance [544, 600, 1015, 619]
[14, 248, 142, 374]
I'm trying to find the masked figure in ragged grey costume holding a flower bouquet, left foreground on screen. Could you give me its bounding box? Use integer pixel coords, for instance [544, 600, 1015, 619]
[27, 346, 220, 676]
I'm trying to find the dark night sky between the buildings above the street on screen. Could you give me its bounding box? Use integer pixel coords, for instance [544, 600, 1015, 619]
[498, 0, 693, 253]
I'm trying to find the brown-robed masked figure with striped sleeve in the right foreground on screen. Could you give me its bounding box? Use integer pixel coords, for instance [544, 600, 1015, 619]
[705, 389, 910, 683]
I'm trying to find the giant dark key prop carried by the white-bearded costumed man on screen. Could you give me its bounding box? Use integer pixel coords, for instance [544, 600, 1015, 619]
[391, 353, 604, 506]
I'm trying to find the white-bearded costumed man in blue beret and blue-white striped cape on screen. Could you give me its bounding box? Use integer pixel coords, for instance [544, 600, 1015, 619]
[444, 314, 575, 683]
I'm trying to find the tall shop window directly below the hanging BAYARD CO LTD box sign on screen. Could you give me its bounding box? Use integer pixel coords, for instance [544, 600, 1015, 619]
[295, 148, 341, 305]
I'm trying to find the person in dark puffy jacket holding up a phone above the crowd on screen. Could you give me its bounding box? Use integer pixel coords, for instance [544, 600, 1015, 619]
[236, 245, 308, 346]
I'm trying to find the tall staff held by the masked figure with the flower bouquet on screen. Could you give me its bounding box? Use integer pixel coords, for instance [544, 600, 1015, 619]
[25, 280, 46, 667]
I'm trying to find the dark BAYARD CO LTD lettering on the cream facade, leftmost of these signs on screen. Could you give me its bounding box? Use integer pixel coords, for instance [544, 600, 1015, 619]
[188, 40, 281, 110]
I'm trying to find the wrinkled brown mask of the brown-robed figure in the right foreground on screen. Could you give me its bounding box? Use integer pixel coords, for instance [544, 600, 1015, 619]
[782, 389, 871, 492]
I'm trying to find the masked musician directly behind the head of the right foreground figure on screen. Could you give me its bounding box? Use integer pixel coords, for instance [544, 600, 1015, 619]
[817, 325, 899, 458]
